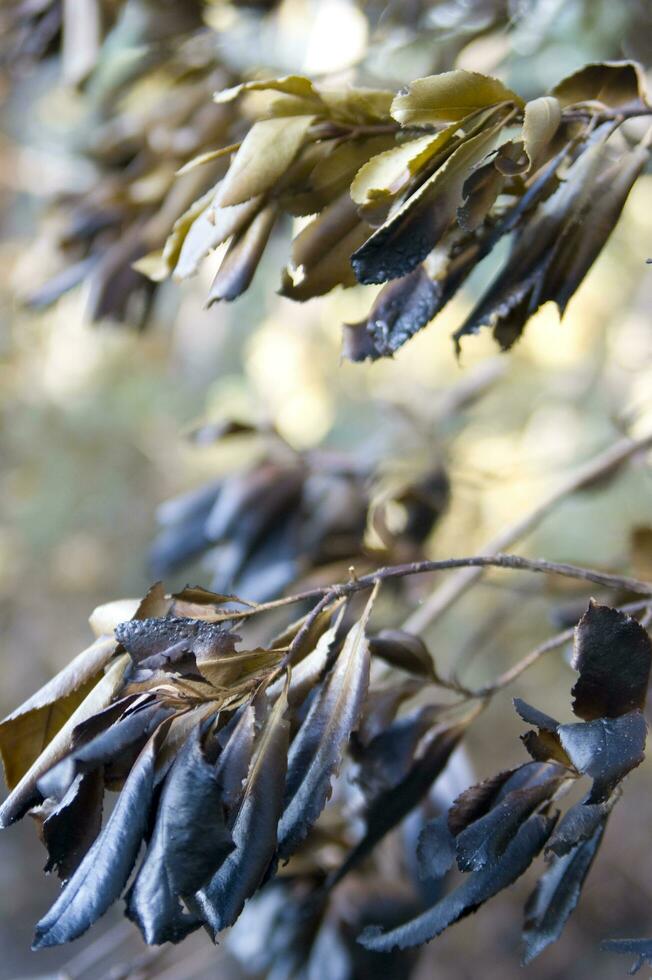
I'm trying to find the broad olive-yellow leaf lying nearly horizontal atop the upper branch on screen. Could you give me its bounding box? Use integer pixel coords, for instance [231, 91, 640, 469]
[392, 68, 523, 126]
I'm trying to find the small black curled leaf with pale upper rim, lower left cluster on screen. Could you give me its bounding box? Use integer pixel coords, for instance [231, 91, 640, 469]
[41, 769, 104, 881]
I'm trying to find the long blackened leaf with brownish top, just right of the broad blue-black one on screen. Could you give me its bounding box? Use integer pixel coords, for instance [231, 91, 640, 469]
[191, 692, 290, 933]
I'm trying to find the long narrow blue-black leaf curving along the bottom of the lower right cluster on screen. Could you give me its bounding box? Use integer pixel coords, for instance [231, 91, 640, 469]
[358, 815, 554, 953]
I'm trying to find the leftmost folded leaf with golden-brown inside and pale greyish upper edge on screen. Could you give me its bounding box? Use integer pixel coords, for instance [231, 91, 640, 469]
[0, 636, 116, 789]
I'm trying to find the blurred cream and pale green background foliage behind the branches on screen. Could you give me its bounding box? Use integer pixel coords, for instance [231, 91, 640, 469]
[0, 0, 652, 980]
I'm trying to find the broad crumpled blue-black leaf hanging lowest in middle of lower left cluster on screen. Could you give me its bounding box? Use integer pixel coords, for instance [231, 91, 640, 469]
[127, 727, 234, 945]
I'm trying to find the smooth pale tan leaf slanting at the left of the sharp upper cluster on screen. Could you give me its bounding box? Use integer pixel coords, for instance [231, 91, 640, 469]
[217, 115, 315, 207]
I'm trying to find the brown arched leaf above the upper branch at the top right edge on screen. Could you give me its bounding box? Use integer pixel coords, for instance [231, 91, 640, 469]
[552, 61, 647, 109]
